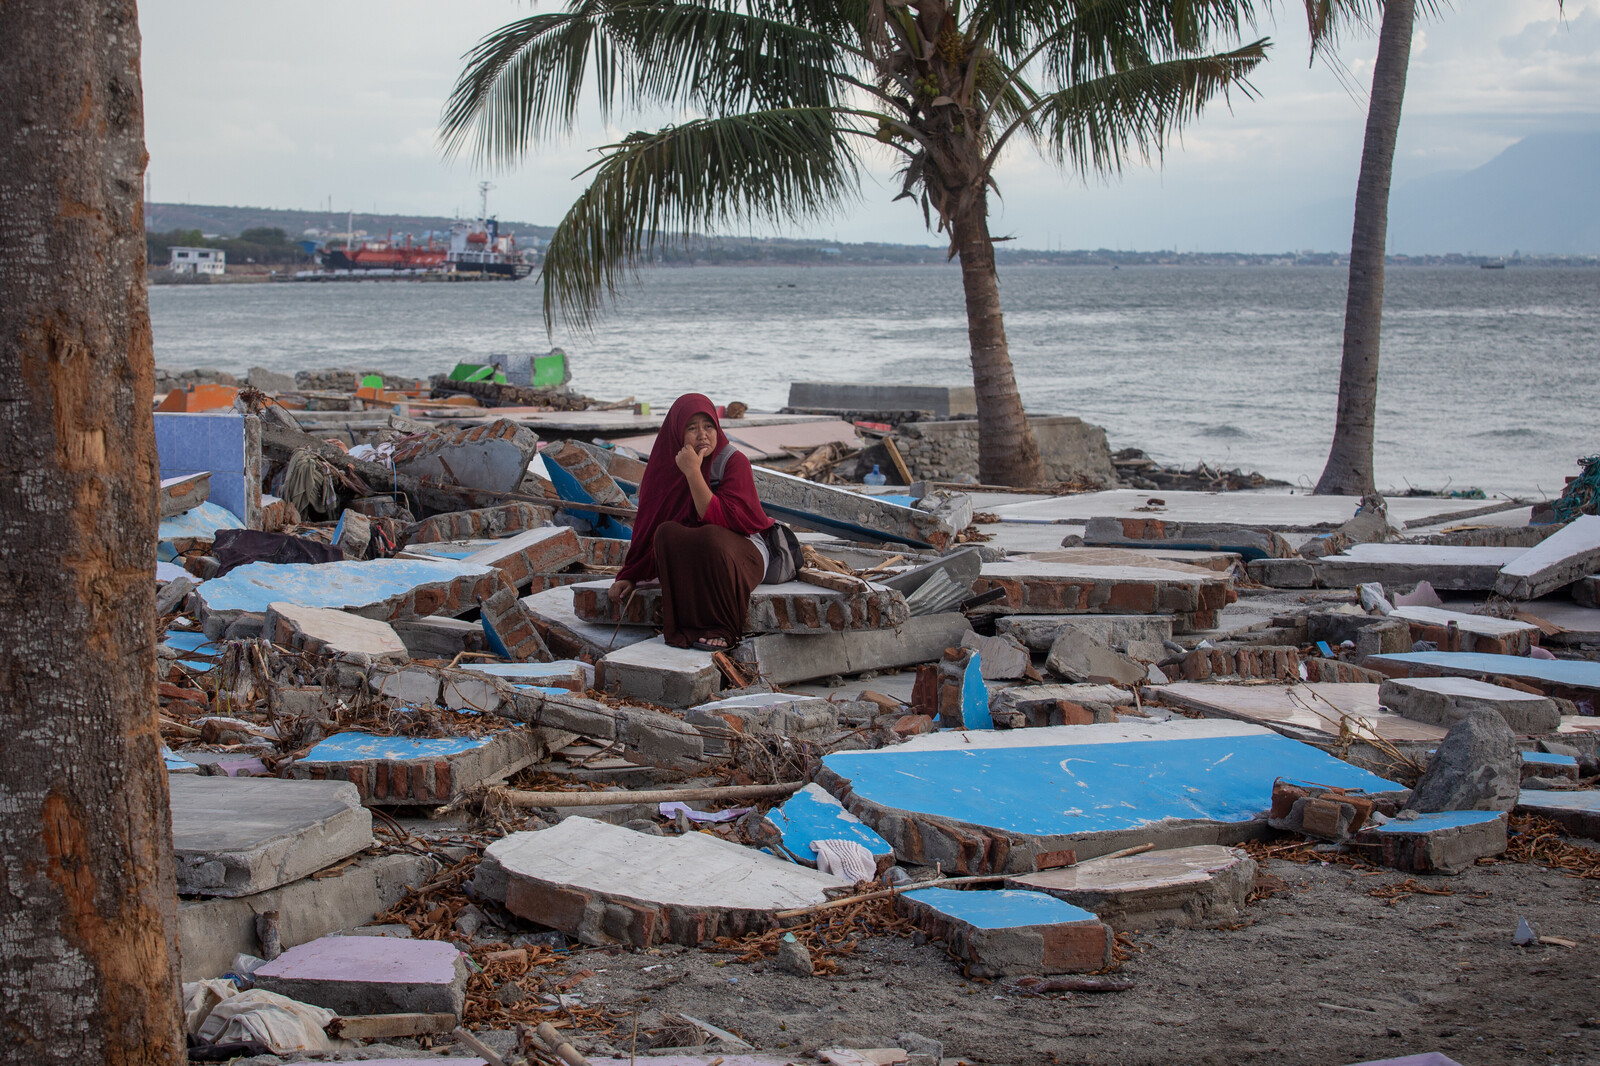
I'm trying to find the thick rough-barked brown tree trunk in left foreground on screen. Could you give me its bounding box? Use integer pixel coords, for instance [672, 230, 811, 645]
[0, 0, 182, 1066]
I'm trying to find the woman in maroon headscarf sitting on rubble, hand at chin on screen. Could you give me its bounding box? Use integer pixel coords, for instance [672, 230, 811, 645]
[610, 392, 792, 651]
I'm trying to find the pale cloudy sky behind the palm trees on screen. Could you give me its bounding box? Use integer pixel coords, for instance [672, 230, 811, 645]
[139, 0, 1600, 251]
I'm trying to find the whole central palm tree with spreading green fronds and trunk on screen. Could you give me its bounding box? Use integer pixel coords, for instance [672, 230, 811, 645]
[442, 0, 1267, 485]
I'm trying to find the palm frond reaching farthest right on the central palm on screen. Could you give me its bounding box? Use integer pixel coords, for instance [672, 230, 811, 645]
[1024, 38, 1267, 176]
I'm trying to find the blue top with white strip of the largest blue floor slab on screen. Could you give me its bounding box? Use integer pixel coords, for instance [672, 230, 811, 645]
[822, 720, 1405, 837]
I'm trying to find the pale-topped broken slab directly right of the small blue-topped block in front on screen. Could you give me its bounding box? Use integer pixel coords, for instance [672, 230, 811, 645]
[1005, 844, 1256, 932]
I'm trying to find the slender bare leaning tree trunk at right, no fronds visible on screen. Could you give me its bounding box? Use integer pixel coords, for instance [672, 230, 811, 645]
[1317, 0, 1416, 496]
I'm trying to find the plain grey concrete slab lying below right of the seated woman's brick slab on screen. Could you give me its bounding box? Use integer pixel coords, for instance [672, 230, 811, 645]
[733, 611, 973, 685]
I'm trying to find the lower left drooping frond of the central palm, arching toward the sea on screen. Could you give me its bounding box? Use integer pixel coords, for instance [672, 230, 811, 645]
[541, 107, 859, 328]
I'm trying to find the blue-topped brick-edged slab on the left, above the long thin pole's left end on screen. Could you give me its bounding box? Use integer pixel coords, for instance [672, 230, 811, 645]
[290, 728, 549, 807]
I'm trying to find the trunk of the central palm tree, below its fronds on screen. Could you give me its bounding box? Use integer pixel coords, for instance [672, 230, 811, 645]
[952, 195, 1045, 487]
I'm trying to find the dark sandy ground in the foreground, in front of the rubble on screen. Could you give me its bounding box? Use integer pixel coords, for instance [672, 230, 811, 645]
[534, 861, 1600, 1066]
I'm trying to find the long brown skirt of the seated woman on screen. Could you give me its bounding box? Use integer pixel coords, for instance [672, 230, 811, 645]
[654, 522, 765, 648]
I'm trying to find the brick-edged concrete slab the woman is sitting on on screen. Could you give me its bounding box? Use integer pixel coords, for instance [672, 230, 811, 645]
[573, 579, 910, 634]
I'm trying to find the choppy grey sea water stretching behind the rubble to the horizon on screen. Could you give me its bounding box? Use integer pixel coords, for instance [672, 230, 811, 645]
[150, 266, 1600, 496]
